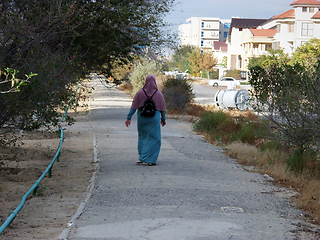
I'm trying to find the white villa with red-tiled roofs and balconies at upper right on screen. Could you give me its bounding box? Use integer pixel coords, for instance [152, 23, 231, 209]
[227, 0, 320, 78]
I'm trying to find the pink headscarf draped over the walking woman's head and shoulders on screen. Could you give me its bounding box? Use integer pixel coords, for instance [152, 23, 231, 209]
[131, 74, 166, 111]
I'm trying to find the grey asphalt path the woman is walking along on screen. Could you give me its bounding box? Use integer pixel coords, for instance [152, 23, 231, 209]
[68, 76, 300, 240]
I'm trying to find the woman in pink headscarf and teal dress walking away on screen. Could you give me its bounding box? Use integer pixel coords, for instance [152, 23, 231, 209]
[125, 75, 166, 166]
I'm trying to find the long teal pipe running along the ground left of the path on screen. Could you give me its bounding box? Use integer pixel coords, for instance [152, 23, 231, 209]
[0, 84, 80, 235]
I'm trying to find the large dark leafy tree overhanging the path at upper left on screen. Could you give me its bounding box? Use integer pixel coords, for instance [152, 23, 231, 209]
[0, 0, 174, 129]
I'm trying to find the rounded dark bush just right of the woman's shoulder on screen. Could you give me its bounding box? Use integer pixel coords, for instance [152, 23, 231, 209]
[162, 78, 194, 114]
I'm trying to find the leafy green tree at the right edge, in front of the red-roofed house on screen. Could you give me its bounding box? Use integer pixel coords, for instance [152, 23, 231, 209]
[249, 47, 320, 170]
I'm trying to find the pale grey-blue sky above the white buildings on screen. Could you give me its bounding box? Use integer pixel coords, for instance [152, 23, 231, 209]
[165, 0, 295, 28]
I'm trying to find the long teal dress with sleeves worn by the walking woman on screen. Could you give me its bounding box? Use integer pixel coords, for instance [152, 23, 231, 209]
[127, 108, 165, 164]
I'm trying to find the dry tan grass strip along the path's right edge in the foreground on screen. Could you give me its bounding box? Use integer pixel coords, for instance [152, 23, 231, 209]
[226, 142, 320, 224]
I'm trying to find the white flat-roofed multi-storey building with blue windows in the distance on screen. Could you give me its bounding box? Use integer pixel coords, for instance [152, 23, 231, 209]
[179, 17, 231, 50]
